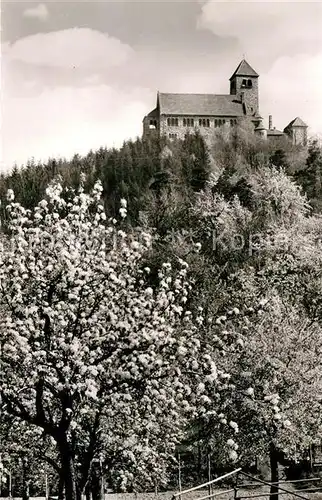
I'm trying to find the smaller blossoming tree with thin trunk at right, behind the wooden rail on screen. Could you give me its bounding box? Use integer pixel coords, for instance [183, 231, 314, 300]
[201, 296, 322, 495]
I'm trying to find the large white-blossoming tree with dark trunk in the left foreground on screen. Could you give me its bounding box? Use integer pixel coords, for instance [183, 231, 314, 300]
[0, 183, 226, 500]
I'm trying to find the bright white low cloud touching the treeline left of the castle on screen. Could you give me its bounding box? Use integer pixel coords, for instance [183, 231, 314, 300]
[2, 85, 149, 168]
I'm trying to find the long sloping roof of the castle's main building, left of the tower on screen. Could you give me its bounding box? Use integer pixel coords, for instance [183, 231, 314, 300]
[158, 92, 244, 116]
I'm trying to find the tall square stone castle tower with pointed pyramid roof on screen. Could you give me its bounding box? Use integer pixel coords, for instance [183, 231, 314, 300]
[230, 59, 259, 116]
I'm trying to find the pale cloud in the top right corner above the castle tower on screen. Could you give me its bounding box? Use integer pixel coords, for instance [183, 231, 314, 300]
[198, 0, 322, 58]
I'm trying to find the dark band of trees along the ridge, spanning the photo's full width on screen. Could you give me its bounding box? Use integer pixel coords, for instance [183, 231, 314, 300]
[0, 133, 322, 225]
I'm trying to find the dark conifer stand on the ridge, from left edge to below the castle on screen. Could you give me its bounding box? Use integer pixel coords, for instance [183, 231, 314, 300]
[0, 135, 209, 224]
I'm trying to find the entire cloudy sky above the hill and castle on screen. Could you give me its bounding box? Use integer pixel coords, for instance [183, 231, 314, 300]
[0, 0, 322, 171]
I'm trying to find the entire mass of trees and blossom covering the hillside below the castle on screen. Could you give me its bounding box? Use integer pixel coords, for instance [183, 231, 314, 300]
[0, 127, 322, 498]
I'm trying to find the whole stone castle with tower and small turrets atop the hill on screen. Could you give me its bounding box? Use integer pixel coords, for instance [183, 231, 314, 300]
[143, 59, 308, 146]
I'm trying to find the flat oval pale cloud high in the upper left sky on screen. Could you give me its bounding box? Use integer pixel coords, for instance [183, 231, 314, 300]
[3, 28, 133, 70]
